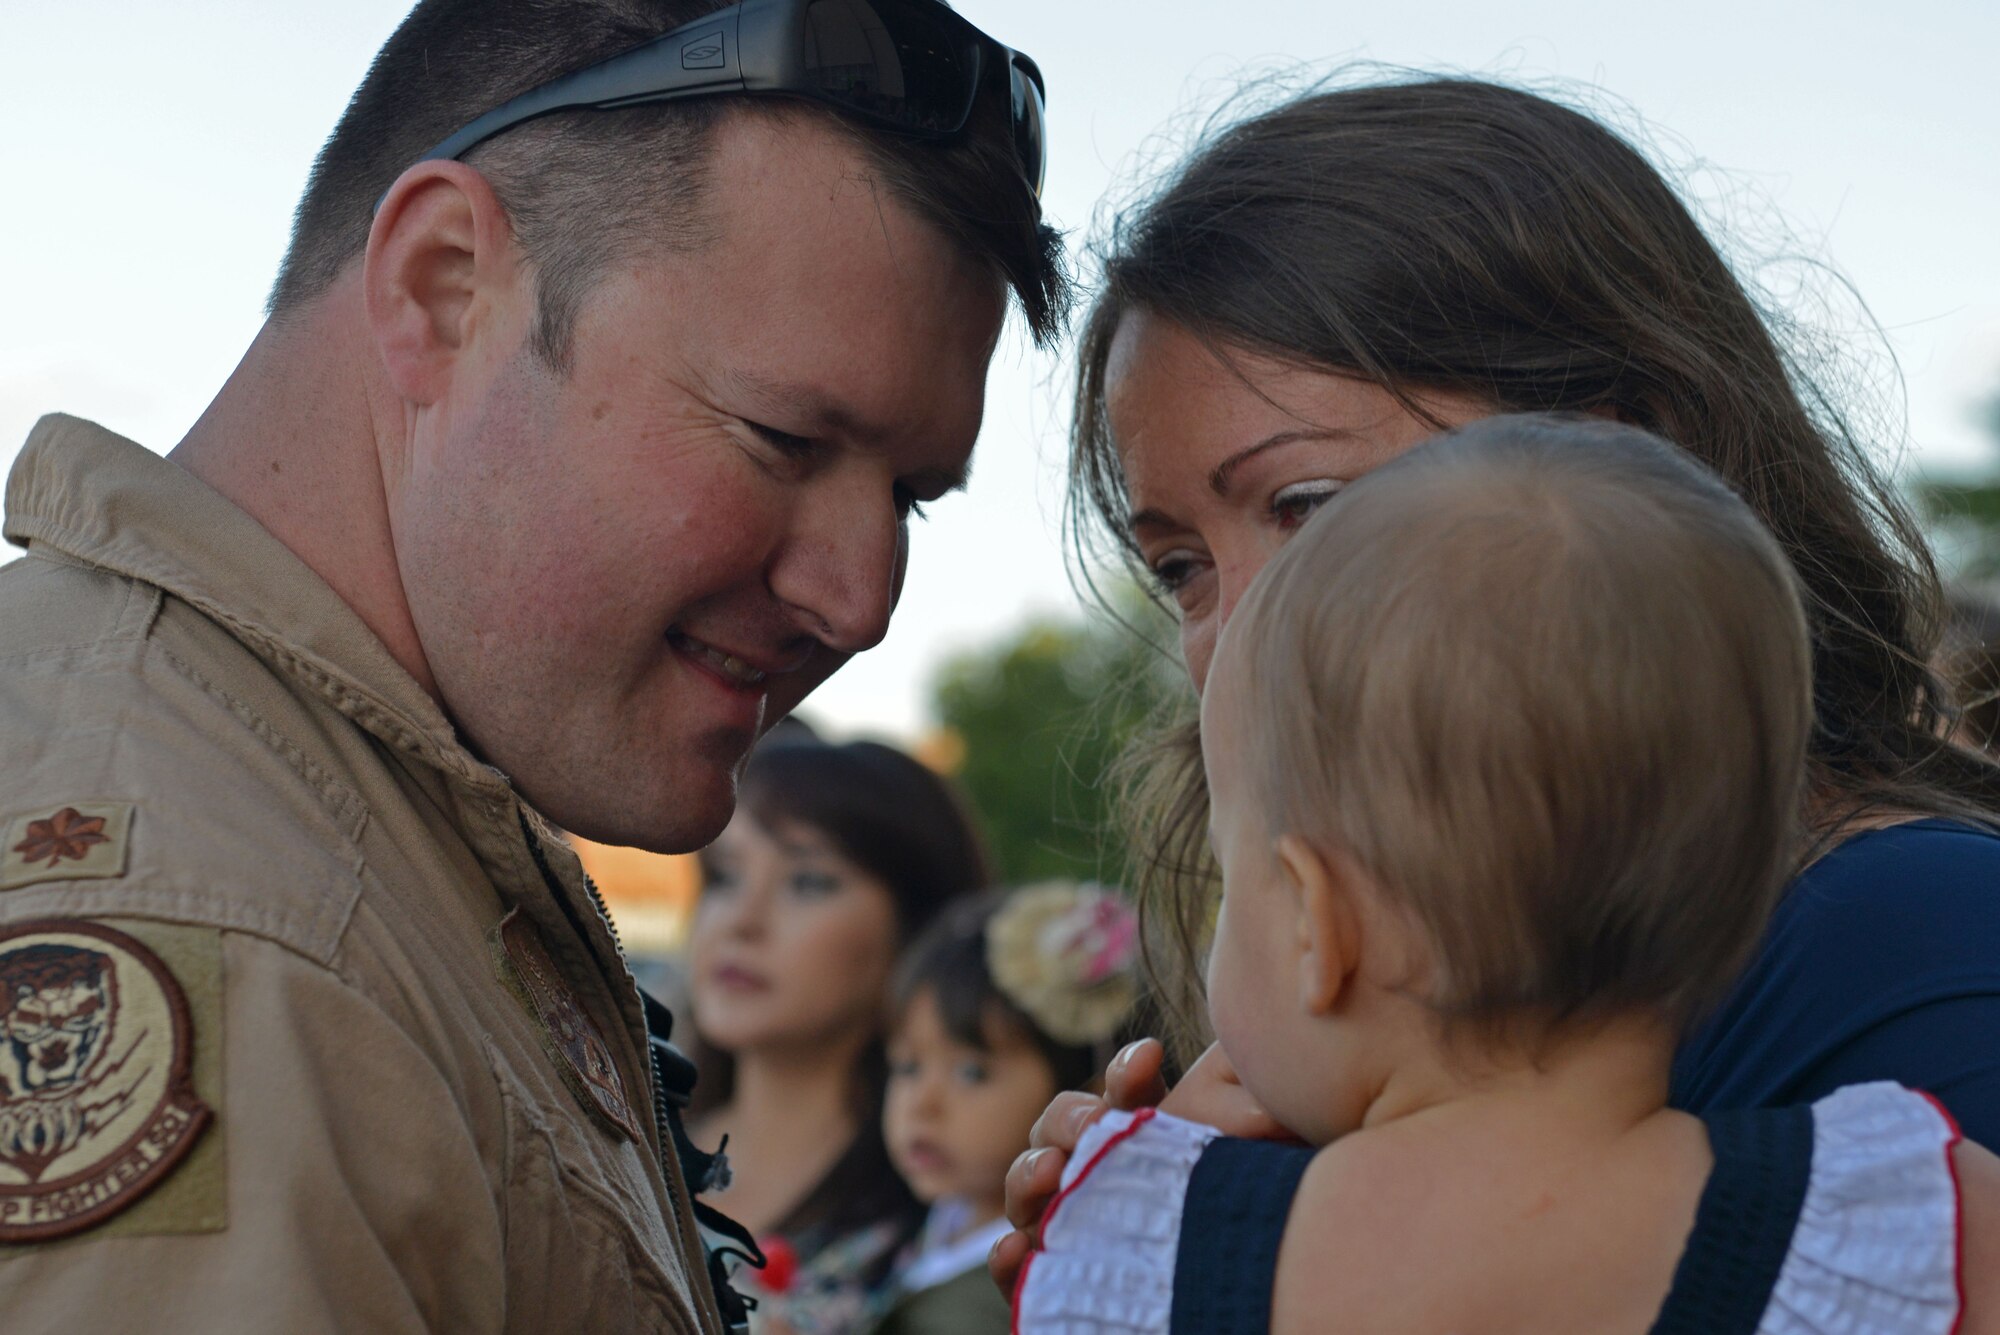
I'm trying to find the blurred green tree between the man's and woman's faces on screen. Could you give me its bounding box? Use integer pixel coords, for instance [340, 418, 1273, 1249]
[932, 594, 1186, 883]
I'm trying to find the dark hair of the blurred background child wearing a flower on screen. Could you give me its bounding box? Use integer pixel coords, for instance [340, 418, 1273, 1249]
[890, 891, 1112, 1089]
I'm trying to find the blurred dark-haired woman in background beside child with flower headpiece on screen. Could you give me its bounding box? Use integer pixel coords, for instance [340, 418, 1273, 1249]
[690, 737, 988, 1335]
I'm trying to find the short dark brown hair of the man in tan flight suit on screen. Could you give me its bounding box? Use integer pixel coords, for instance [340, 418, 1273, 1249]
[270, 0, 1068, 368]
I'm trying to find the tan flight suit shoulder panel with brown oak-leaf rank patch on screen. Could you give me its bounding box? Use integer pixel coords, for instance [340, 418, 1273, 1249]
[0, 556, 366, 961]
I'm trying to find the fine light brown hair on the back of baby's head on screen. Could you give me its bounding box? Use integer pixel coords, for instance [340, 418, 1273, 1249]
[1226, 416, 1812, 1025]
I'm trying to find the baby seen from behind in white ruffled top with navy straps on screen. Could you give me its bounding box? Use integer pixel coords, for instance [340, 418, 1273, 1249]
[1016, 418, 2000, 1335]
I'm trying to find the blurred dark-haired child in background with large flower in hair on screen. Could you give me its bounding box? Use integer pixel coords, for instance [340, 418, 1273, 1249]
[876, 881, 1138, 1335]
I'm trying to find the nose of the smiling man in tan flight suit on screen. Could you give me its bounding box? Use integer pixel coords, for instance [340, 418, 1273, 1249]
[770, 484, 908, 654]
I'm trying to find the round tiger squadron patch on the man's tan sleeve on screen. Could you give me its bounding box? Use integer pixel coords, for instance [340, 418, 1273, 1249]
[0, 919, 212, 1243]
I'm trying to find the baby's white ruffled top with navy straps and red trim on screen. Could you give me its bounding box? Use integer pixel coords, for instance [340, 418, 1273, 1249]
[1014, 1083, 1962, 1335]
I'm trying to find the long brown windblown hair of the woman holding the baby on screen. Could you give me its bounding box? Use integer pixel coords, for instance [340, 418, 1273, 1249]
[1068, 78, 2000, 1047]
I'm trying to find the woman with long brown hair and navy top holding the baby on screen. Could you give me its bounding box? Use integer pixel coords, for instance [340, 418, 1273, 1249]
[994, 78, 2000, 1275]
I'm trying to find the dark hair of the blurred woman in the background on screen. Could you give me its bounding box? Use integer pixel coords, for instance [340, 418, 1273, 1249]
[690, 731, 990, 1265]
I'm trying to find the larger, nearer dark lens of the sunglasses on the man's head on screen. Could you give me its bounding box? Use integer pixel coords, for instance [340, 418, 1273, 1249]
[806, 0, 980, 134]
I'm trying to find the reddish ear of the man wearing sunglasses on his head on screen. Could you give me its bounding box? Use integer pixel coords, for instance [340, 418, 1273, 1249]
[362, 162, 520, 404]
